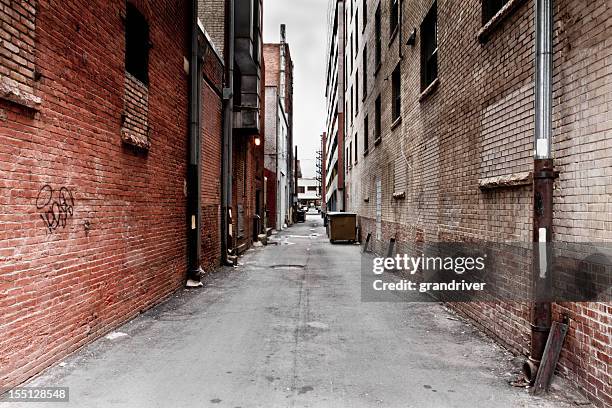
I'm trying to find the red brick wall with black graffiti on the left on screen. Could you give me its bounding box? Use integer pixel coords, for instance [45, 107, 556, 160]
[0, 0, 189, 386]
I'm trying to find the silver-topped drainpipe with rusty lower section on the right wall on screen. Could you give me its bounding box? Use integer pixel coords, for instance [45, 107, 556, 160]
[523, 0, 555, 383]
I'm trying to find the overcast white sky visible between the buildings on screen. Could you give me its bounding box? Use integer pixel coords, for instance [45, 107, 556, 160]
[263, 0, 327, 177]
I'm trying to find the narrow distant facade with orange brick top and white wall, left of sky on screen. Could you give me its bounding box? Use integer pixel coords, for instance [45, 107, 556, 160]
[264, 24, 295, 230]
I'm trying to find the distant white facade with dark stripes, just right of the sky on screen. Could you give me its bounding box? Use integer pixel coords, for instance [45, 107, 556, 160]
[323, 0, 352, 211]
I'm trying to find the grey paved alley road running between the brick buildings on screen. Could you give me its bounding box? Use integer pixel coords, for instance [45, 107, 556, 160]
[0, 215, 580, 408]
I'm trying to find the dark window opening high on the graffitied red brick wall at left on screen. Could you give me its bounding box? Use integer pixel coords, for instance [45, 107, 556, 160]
[125, 3, 149, 84]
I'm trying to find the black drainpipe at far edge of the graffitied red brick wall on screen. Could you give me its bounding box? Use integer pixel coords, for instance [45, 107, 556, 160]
[187, 0, 202, 286]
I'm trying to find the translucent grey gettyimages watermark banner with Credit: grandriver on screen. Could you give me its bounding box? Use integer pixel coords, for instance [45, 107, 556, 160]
[361, 242, 612, 302]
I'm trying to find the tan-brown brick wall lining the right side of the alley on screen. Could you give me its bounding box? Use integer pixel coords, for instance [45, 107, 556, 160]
[346, 0, 612, 406]
